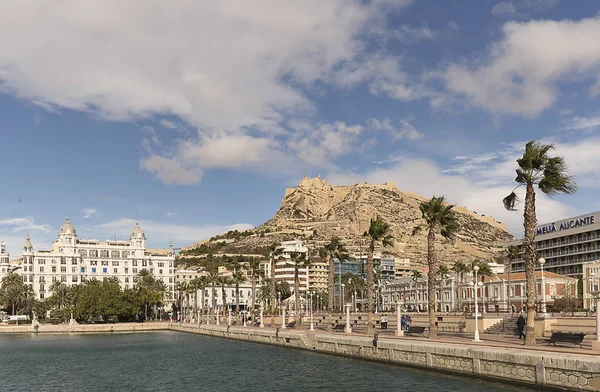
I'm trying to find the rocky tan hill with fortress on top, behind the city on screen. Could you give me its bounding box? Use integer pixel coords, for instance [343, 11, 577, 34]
[180, 178, 513, 266]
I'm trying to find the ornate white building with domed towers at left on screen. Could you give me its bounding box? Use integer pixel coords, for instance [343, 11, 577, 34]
[19, 218, 175, 301]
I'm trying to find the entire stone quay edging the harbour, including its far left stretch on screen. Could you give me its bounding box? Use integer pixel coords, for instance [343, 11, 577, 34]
[0, 322, 600, 391]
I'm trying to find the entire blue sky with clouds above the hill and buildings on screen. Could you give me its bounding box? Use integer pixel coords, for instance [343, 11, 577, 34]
[0, 0, 600, 257]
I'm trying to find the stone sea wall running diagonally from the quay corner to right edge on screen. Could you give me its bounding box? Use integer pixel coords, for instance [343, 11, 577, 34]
[171, 325, 600, 391]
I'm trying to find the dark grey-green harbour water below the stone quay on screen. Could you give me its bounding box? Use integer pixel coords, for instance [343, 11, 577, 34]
[0, 332, 533, 392]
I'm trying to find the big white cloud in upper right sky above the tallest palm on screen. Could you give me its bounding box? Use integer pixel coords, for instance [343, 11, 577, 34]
[443, 16, 600, 117]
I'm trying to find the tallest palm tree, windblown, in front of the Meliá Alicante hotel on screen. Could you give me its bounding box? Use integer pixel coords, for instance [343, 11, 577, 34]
[502, 140, 577, 345]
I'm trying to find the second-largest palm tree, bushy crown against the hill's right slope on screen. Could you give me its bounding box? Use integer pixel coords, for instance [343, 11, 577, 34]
[415, 196, 459, 339]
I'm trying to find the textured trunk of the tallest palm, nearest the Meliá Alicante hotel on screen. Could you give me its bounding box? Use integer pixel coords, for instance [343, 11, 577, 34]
[523, 184, 537, 346]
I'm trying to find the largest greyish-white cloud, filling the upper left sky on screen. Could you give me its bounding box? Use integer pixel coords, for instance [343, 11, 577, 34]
[0, 0, 422, 184]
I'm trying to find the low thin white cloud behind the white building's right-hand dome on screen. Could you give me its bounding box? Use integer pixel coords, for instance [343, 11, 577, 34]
[98, 219, 254, 247]
